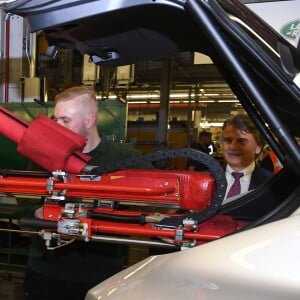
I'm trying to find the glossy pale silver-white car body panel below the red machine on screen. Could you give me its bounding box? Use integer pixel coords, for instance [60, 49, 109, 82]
[86, 215, 300, 300]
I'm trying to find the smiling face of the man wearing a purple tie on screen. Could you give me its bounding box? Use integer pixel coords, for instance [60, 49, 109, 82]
[222, 126, 261, 171]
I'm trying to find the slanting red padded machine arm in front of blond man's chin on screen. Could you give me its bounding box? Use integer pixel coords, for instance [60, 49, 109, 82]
[0, 107, 91, 173]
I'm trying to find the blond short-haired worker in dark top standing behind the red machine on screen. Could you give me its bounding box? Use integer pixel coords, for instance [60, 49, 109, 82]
[19, 86, 152, 300]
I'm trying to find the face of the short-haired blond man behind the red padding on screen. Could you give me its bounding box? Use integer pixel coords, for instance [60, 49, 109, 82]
[54, 101, 86, 136]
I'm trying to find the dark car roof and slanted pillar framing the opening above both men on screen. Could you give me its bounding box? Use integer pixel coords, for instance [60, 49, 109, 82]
[5, 0, 300, 173]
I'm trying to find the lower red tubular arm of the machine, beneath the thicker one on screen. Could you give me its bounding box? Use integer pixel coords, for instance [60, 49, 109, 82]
[44, 204, 245, 245]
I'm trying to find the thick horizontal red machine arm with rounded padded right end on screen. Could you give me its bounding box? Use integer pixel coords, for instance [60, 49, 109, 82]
[0, 169, 215, 210]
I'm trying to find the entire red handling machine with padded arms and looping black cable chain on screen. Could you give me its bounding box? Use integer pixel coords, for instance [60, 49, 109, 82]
[0, 107, 244, 249]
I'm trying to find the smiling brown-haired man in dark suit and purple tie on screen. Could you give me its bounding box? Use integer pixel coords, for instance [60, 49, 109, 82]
[222, 114, 272, 204]
